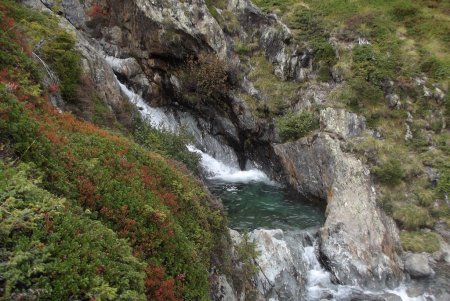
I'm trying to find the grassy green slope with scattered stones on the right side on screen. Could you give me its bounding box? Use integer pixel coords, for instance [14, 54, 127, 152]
[250, 0, 450, 251]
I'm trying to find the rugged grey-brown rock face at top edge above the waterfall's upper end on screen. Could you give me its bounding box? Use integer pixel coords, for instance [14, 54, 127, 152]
[98, 0, 227, 60]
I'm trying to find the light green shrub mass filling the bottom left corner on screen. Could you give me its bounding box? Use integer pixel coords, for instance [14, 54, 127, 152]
[0, 161, 145, 300]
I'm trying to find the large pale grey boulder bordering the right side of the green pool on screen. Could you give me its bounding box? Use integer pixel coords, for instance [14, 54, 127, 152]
[274, 133, 402, 287]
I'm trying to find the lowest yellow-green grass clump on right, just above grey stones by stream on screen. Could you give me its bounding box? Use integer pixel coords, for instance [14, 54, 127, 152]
[400, 231, 440, 253]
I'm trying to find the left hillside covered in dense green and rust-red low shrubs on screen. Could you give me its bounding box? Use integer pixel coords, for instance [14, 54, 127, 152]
[0, 1, 225, 300]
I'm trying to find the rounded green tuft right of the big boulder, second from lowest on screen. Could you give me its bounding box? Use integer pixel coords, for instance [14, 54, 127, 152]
[392, 204, 431, 231]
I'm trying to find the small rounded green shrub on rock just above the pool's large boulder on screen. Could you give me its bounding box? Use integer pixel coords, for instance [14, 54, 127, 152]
[276, 111, 318, 142]
